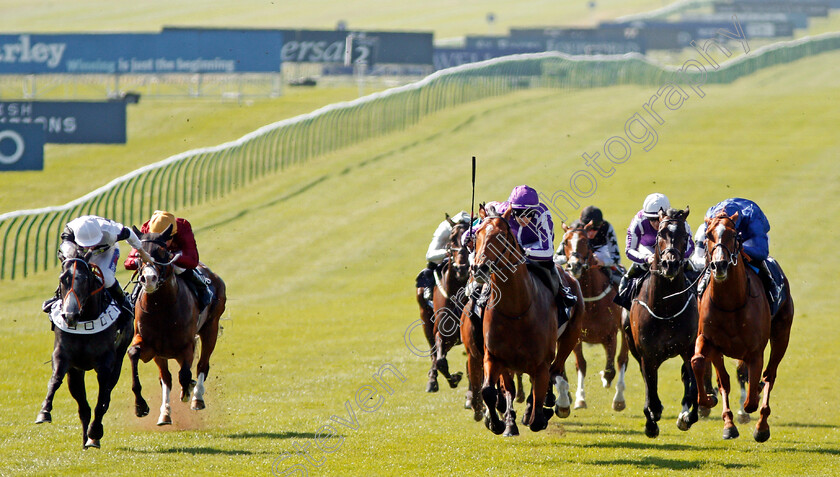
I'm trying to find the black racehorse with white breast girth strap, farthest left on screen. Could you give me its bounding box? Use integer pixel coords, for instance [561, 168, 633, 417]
[35, 252, 132, 448]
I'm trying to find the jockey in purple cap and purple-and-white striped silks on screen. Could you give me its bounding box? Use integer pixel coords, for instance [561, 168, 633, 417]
[465, 185, 576, 326]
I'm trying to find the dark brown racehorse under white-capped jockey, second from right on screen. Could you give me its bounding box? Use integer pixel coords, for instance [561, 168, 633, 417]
[623, 207, 704, 438]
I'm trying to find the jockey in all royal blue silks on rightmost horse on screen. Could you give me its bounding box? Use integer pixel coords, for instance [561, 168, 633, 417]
[697, 197, 784, 316]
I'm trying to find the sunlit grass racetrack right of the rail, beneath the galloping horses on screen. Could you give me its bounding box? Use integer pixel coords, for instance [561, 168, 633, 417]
[0, 46, 840, 475]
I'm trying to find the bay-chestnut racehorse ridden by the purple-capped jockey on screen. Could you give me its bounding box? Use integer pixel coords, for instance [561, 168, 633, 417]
[470, 207, 579, 436]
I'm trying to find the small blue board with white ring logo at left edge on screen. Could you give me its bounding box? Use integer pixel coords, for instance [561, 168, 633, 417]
[0, 124, 44, 171]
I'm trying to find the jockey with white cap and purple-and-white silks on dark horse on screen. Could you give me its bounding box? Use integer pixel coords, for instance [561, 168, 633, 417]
[615, 193, 694, 310]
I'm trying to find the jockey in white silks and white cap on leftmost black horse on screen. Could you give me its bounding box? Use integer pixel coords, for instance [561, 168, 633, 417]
[43, 215, 152, 316]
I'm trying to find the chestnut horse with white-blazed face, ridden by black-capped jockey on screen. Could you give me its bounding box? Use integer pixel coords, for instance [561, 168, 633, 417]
[563, 221, 627, 411]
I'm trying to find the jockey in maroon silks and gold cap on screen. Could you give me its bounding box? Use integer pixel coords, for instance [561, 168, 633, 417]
[123, 210, 213, 313]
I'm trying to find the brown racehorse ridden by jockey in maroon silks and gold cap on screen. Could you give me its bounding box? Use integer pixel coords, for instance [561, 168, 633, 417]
[128, 226, 227, 426]
